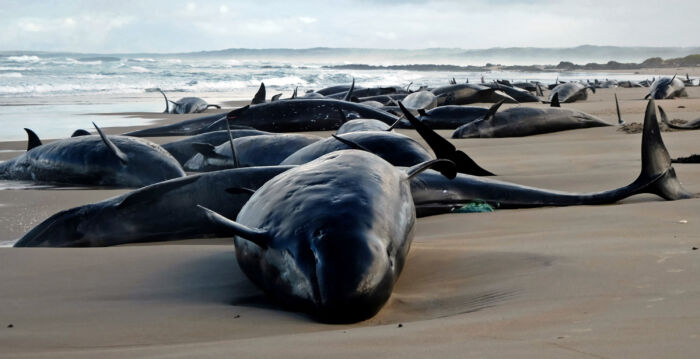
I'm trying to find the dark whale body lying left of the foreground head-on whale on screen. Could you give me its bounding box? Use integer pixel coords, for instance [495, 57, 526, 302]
[14, 166, 291, 247]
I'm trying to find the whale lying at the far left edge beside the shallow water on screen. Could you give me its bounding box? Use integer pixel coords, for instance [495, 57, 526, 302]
[0, 125, 185, 187]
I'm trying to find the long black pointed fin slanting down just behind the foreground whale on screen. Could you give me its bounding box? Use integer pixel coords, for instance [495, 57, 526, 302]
[399, 101, 493, 176]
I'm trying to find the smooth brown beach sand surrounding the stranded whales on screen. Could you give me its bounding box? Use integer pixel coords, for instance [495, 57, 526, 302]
[0, 87, 700, 358]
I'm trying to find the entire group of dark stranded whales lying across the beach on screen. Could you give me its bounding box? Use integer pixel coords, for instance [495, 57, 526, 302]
[0, 76, 700, 323]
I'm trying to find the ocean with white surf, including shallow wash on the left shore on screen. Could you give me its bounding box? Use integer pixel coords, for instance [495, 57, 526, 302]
[0, 53, 654, 140]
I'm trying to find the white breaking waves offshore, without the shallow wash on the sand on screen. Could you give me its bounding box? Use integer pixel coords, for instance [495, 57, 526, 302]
[0, 54, 653, 99]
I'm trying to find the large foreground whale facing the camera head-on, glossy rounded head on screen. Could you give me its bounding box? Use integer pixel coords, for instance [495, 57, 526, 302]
[200, 150, 456, 323]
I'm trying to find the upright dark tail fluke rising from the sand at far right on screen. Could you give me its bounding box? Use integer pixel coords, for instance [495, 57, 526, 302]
[633, 100, 694, 200]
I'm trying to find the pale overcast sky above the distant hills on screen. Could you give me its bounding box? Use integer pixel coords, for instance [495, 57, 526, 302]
[0, 0, 700, 53]
